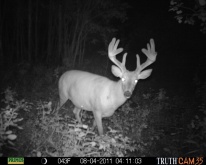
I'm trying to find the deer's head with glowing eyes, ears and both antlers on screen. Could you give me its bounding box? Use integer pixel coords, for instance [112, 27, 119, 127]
[108, 38, 157, 98]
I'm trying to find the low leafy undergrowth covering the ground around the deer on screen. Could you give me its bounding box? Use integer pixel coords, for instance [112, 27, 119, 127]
[0, 66, 206, 157]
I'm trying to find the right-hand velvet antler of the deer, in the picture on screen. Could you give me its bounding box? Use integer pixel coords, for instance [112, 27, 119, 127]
[139, 39, 157, 72]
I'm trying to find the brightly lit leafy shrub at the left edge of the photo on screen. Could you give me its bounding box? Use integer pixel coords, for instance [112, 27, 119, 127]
[0, 88, 31, 156]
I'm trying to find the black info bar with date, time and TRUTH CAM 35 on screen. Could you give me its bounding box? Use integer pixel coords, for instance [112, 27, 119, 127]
[0, 157, 206, 165]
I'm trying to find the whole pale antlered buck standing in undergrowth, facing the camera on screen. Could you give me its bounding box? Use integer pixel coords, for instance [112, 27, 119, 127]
[59, 38, 157, 135]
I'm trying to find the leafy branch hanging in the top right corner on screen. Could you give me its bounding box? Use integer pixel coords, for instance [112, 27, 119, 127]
[169, 0, 206, 33]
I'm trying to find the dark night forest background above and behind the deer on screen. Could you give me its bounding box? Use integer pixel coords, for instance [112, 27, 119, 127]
[0, 0, 206, 90]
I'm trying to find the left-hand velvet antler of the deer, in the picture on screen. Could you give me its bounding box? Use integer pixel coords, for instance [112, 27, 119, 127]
[108, 38, 127, 70]
